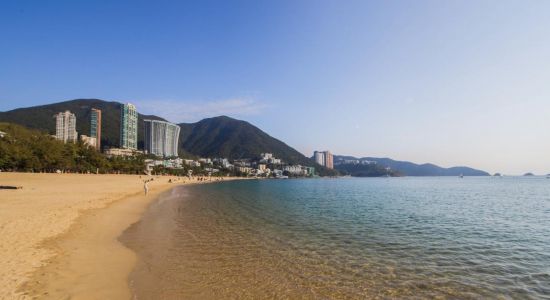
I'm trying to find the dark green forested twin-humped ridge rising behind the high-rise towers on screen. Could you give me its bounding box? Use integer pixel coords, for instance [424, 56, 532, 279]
[0, 99, 337, 175]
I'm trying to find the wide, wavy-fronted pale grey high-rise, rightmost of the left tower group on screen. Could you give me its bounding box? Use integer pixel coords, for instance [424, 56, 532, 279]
[144, 120, 180, 157]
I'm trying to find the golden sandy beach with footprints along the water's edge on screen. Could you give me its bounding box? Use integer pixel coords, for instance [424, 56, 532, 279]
[0, 173, 231, 299]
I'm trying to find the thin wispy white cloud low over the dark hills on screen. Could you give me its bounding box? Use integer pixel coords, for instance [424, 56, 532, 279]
[130, 98, 266, 123]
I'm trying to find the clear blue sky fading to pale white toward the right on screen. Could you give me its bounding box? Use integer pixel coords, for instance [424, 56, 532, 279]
[0, 0, 550, 174]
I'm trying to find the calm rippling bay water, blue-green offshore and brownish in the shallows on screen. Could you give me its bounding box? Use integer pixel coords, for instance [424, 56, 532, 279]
[122, 177, 550, 299]
